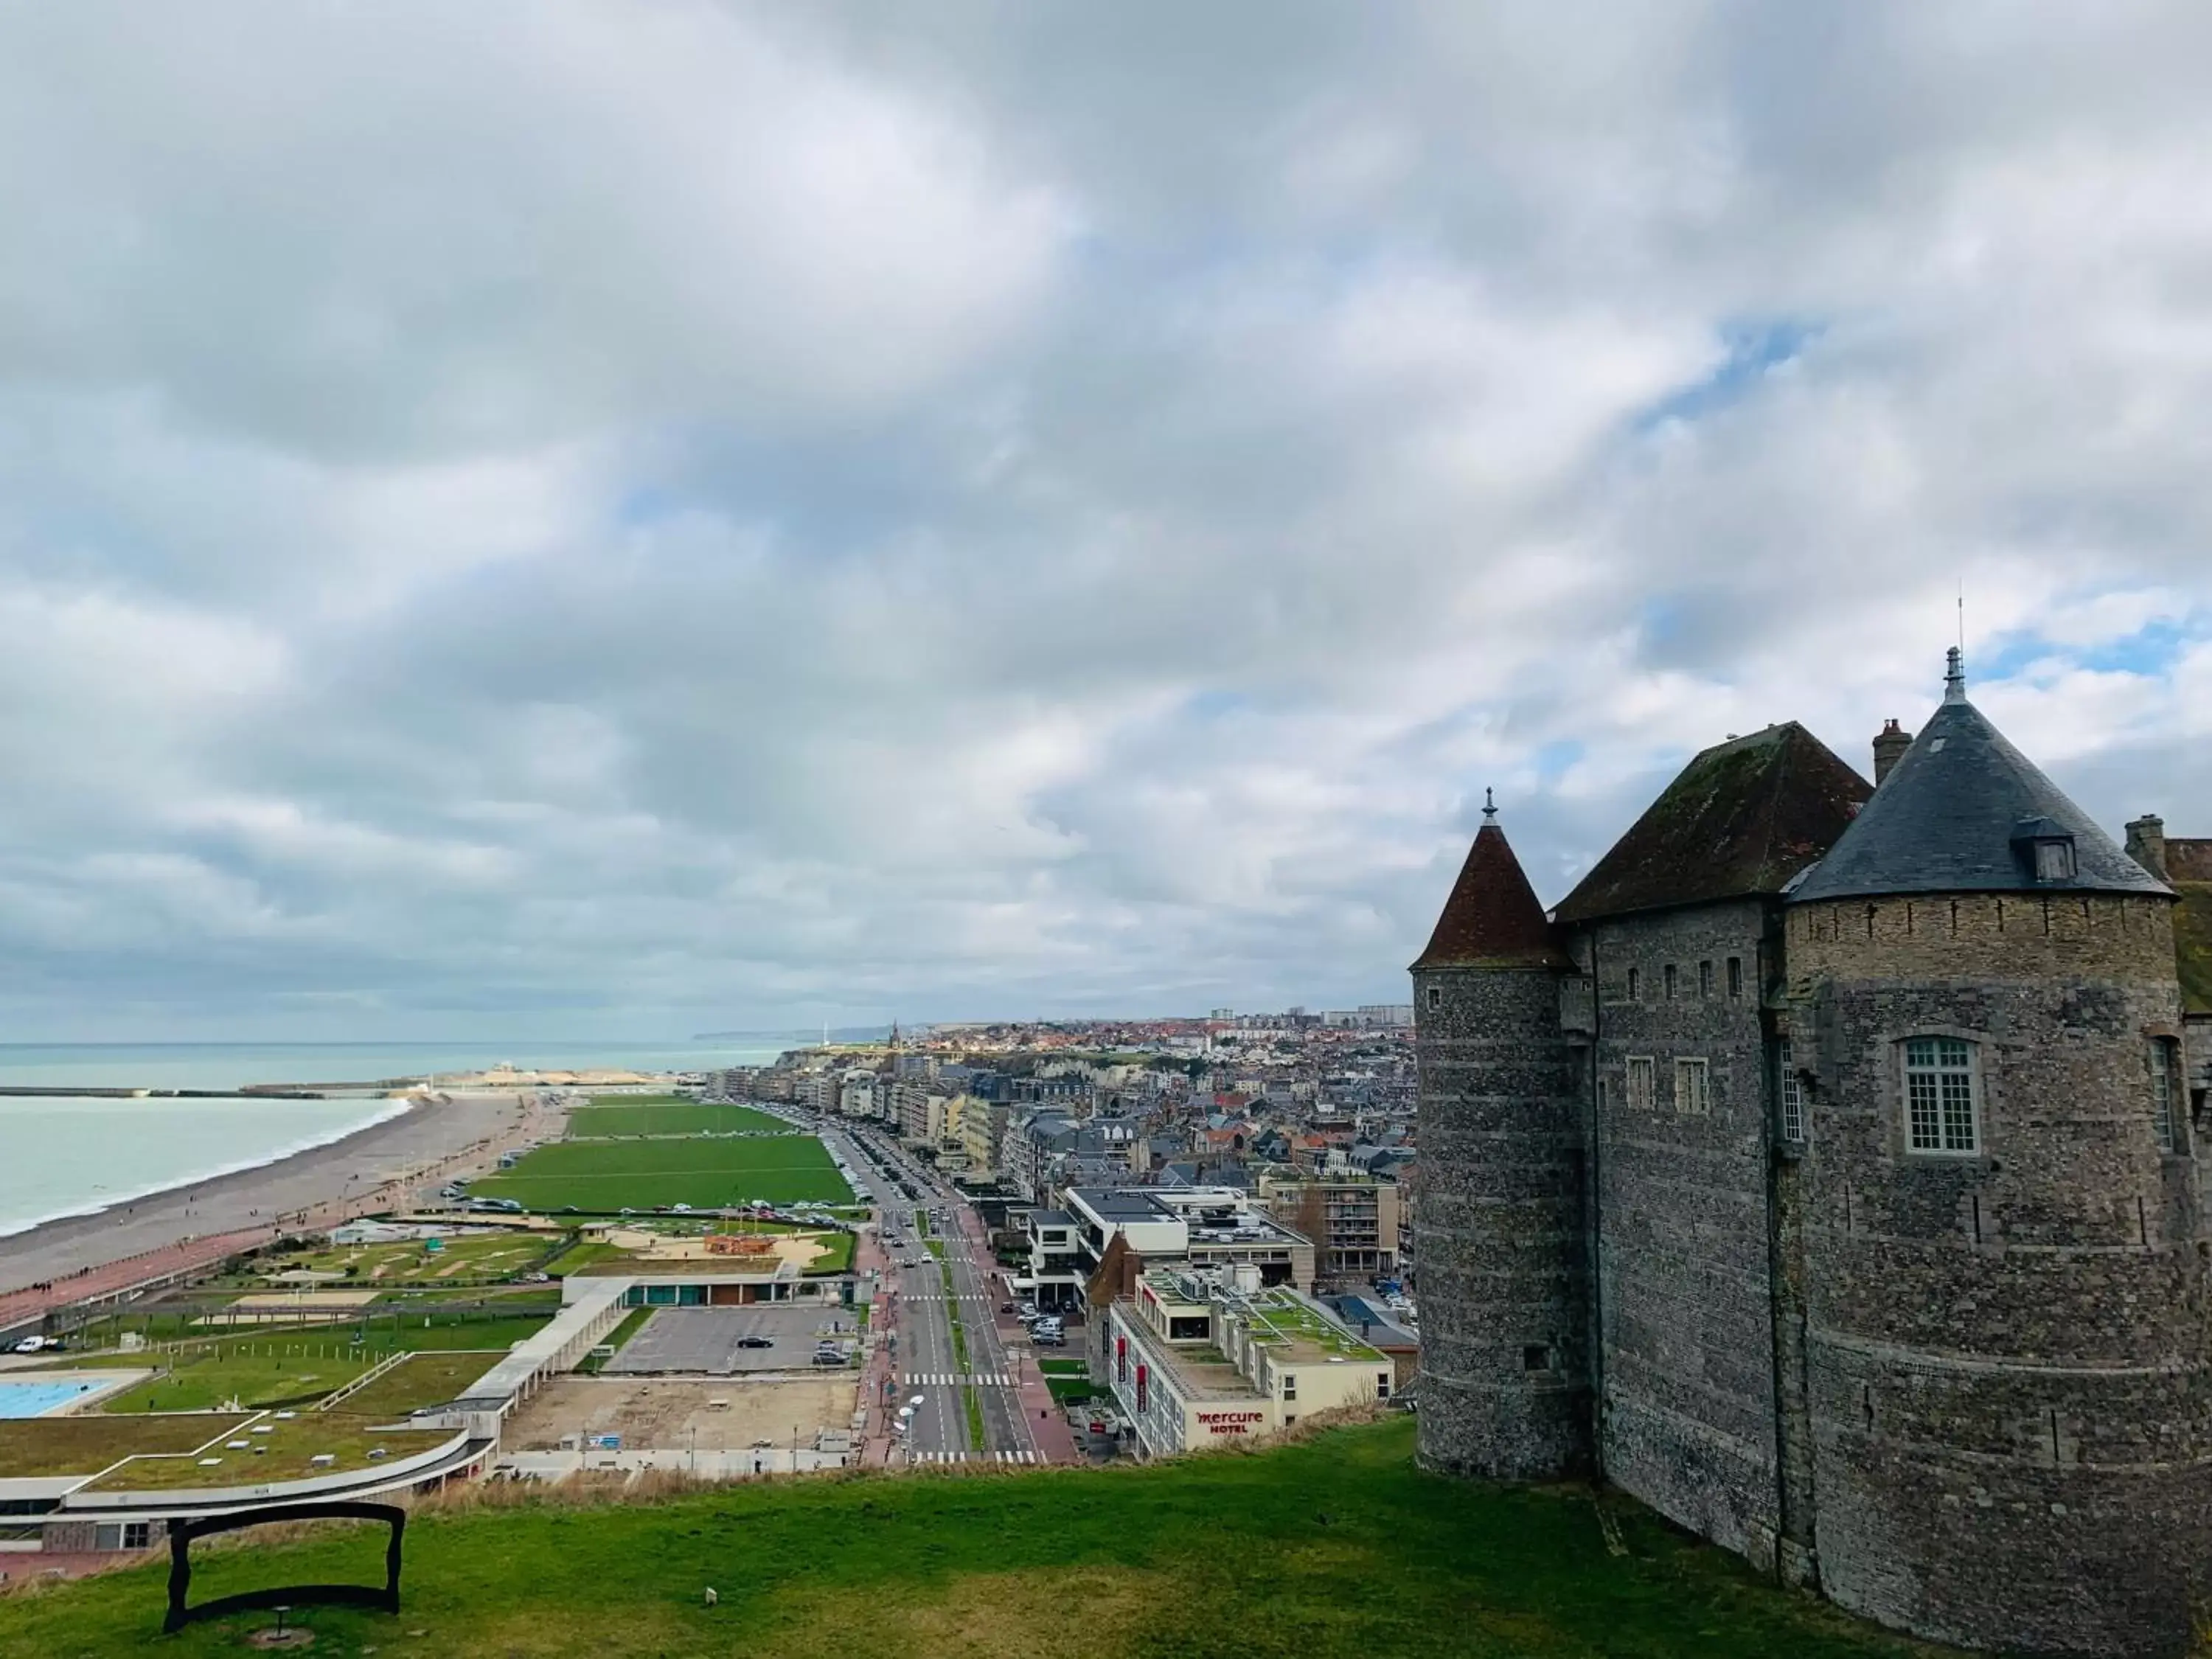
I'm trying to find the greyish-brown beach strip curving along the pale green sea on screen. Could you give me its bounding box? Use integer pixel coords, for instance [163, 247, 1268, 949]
[0, 1093, 564, 1327]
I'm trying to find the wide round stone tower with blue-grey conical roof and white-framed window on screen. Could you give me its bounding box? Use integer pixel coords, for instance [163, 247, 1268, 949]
[1785, 653, 2212, 1655]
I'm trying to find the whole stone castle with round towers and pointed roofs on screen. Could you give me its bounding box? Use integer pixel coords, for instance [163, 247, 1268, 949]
[1411, 653, 2212, 1655]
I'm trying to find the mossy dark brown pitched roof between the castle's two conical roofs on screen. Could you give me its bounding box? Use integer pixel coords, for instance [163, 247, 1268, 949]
[1557, 721, 1871, 922]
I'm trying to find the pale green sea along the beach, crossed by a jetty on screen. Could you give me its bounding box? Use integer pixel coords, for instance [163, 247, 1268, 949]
[0, 1033, 818, 1237]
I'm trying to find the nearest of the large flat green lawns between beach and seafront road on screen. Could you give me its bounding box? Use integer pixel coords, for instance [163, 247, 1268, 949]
[471, 1135, 852, 1214]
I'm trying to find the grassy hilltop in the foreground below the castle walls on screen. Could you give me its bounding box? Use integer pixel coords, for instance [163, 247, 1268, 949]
[0, 1418, 1927, 1659]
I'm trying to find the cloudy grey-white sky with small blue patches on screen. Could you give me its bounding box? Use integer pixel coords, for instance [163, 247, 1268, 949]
[0, 0, 2212, 1042]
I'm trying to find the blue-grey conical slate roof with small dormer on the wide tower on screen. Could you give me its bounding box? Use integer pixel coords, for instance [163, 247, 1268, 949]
[1790, 653, 2172, 905]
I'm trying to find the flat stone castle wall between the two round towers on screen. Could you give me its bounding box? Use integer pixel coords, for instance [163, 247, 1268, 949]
[1584, 900, 1783, 1566]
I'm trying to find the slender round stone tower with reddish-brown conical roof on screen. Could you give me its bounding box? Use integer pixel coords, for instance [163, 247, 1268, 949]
[1411, 805, 1590, 1480]
